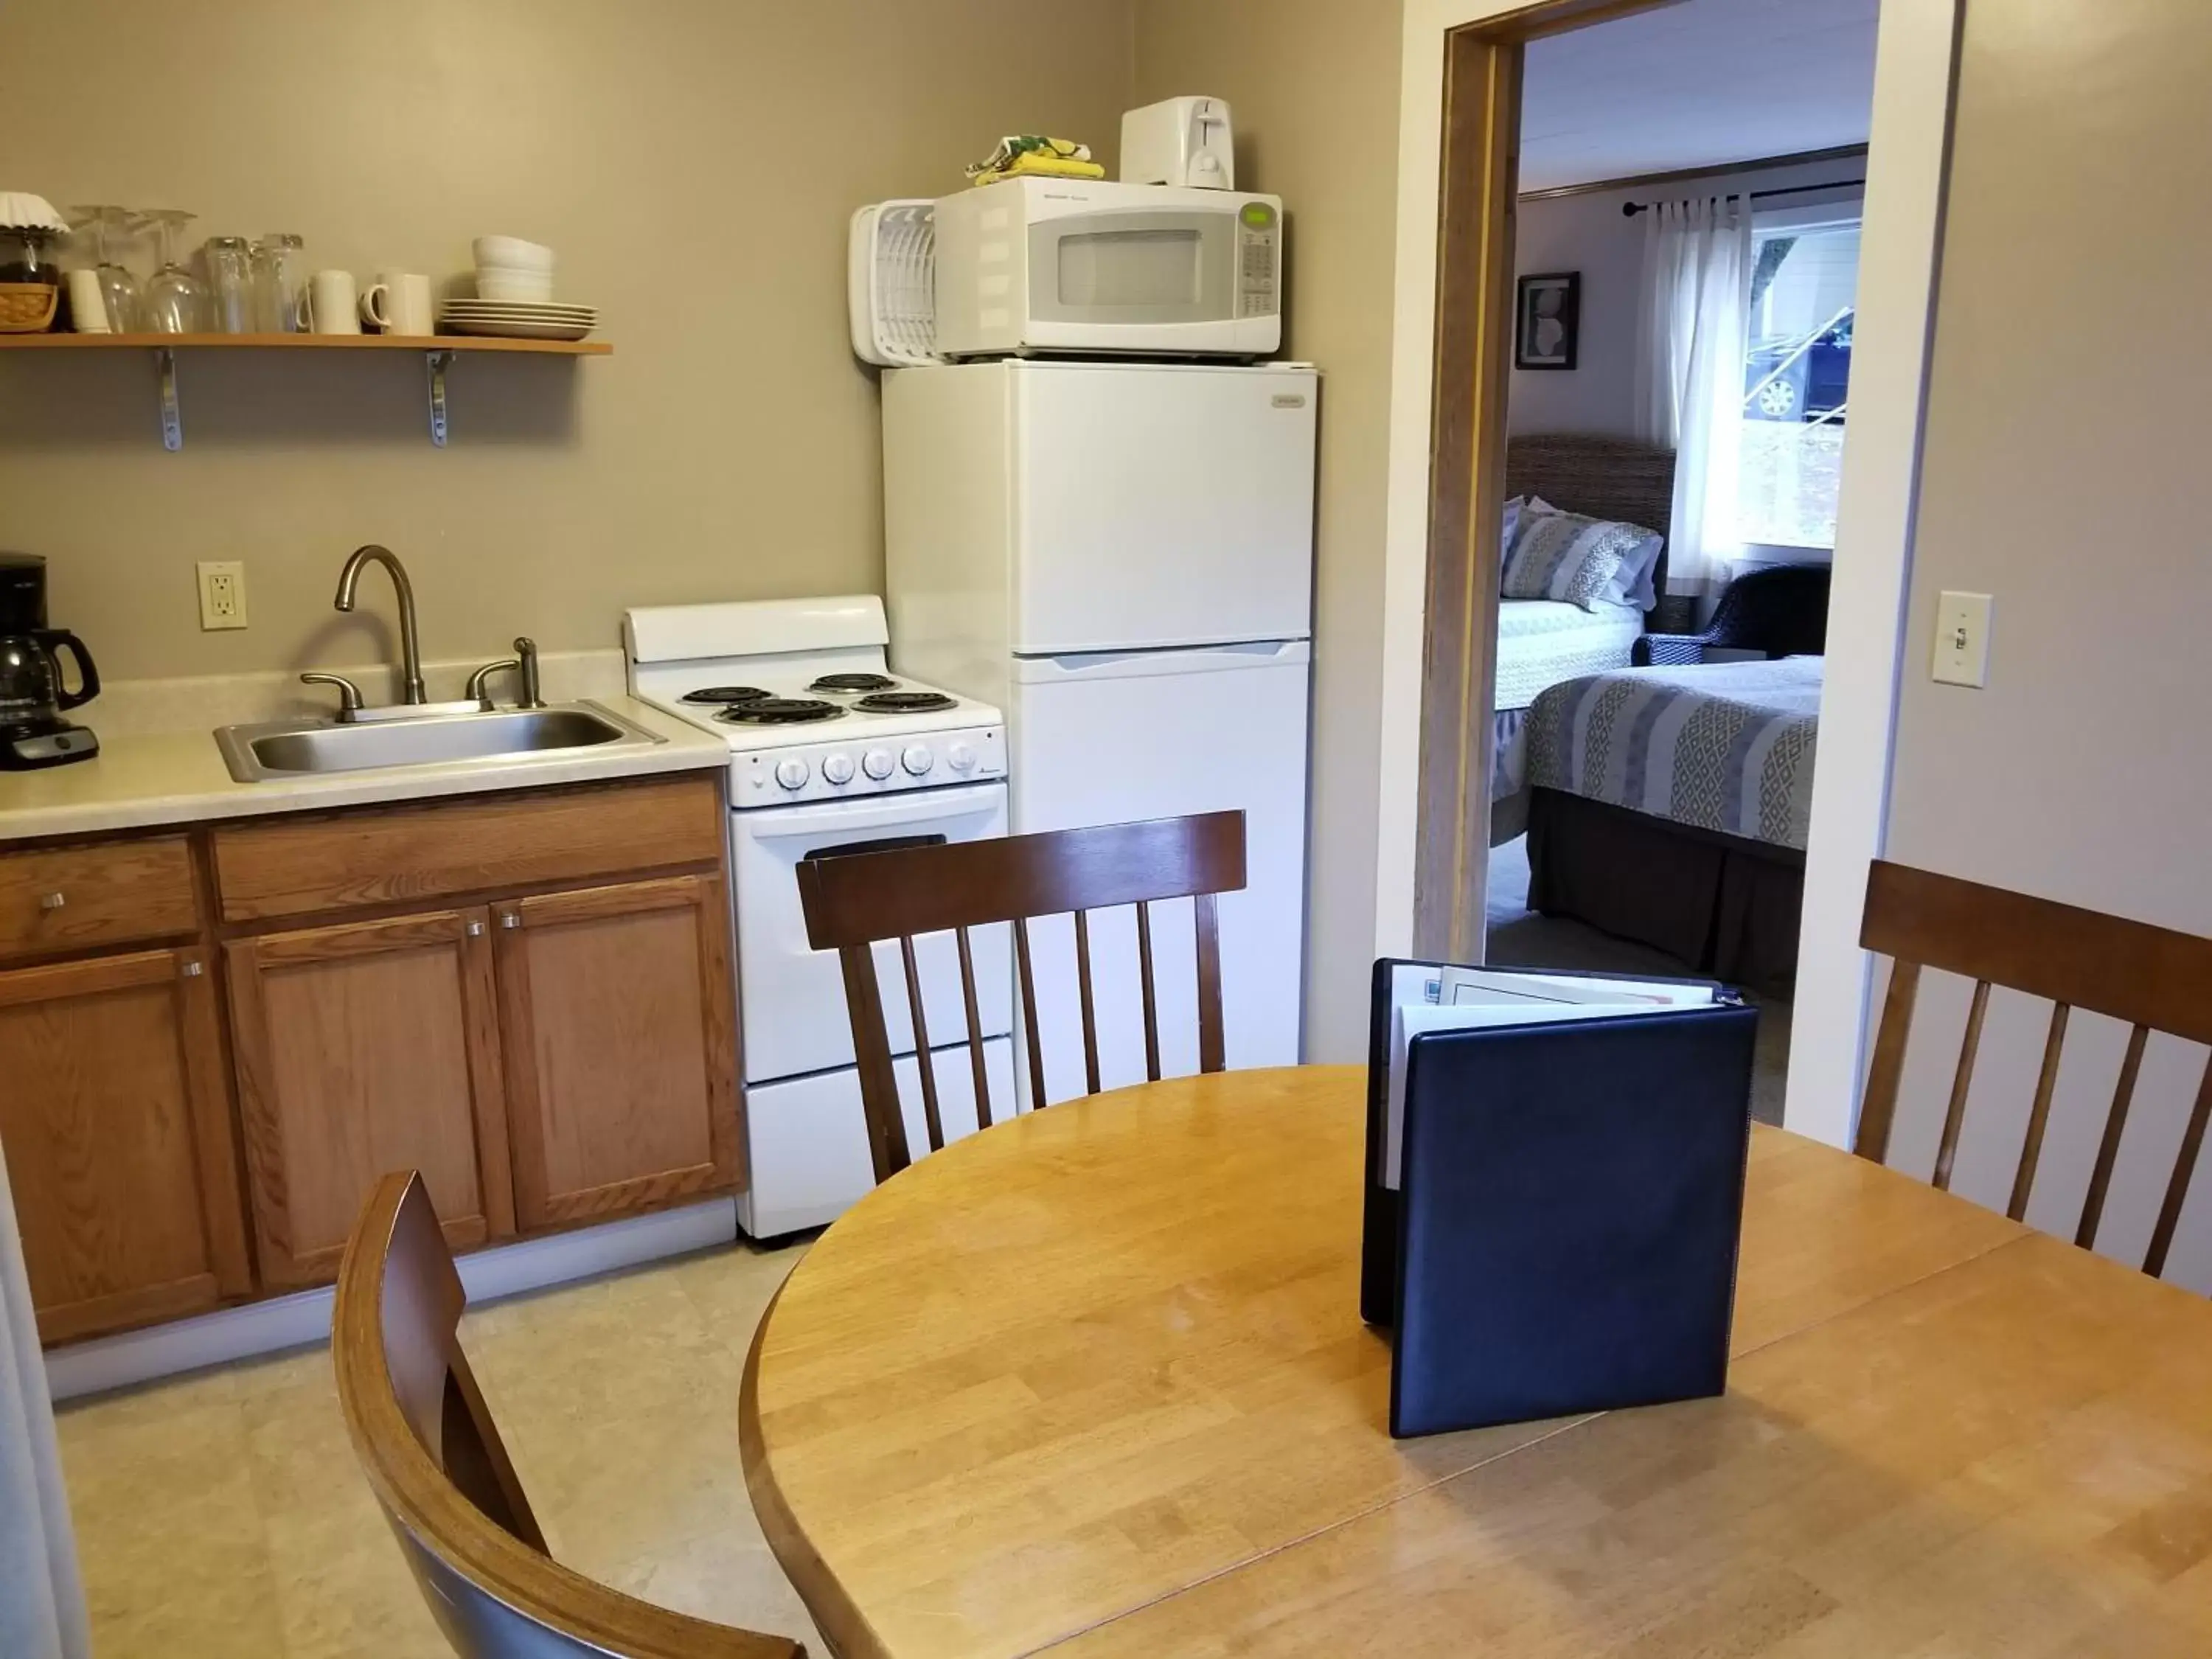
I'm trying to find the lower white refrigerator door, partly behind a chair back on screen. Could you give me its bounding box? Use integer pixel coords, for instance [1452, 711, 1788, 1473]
[1011, 641, 1310, 1102]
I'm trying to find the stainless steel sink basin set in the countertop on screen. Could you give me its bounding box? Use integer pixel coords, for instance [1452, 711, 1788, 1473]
[215, 703, 666, 783]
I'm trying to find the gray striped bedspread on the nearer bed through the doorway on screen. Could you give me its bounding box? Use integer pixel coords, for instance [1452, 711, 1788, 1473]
[1524, 657, 1820, 849]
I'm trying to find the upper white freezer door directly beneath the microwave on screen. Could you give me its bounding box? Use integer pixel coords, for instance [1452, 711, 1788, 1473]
[1011, 363, 1318, 657]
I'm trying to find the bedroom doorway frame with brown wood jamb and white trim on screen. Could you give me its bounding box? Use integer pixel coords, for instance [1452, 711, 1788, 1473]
[1376, 0, 1962, 1146]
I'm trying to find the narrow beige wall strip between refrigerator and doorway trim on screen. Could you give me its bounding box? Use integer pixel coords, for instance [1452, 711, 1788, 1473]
[1135, 0, 1398, 1060]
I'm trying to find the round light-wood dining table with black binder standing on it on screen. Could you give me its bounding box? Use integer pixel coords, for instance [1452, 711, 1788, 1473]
[741, 1068, 2212, 1659]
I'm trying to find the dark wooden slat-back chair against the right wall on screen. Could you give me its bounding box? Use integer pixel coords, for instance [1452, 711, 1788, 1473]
[1851, 863, 2212, 1279]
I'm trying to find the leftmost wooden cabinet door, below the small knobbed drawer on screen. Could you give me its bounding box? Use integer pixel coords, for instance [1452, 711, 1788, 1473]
[0, 951, 252, 1343]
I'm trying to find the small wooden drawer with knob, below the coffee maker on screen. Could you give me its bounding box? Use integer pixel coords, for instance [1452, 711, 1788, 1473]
[0, 836, 199, 956]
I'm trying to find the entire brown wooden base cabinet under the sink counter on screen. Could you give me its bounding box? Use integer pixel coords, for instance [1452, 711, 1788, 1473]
[0, 772, 743, 1343]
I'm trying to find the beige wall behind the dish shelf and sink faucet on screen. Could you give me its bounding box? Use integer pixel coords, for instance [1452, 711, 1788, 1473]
[0, 0, 1130, 677]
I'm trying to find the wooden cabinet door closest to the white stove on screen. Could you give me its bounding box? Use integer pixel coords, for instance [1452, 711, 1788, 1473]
[495, 876, 743, 1228]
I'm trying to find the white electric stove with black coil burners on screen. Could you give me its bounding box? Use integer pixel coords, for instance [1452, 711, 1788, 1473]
[622, 595, 1015, 1239]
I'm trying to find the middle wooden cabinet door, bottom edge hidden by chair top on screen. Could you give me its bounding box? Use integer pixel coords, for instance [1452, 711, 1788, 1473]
[228, 909, 515, 1287]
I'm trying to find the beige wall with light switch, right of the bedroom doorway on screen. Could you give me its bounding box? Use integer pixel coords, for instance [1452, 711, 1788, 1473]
[1889, 0, 2212, 1290]
